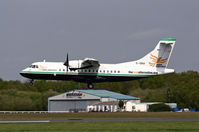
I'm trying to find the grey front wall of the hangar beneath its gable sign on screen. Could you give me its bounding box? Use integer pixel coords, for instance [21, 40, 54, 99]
[48, 99, 100, 112]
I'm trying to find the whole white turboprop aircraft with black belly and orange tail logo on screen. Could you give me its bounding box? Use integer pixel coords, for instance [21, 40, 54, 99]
[20, 38, 176, 88]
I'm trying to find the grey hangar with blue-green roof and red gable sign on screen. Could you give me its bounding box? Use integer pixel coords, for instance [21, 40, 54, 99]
[48, 90, 140, 112]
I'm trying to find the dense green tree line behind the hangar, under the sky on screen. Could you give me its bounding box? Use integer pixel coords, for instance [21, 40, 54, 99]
[0, 71, 199, 111]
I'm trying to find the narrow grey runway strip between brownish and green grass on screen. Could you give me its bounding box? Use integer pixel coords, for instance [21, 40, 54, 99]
[0, 118, 199, 123]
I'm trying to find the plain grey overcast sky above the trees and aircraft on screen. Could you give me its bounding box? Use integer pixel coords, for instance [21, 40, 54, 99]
[0, 0, 199, 80]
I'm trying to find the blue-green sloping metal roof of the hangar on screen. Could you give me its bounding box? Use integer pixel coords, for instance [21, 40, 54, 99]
[75, 90, 140, 100]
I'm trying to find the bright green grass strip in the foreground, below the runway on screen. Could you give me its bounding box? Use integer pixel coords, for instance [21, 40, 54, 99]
[0, 122, 199, 132]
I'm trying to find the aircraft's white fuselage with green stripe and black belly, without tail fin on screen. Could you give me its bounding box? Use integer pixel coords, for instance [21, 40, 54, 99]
[20, 60, 174, 82]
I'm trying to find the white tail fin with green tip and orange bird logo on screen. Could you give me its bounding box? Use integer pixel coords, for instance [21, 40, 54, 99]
[136, 38, 176, 68]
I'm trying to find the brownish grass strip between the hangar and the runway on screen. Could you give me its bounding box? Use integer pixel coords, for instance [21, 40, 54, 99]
[0, 112, 199, 120]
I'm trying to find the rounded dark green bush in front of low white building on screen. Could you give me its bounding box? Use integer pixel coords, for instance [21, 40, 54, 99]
[149, 103, 171, 112]
